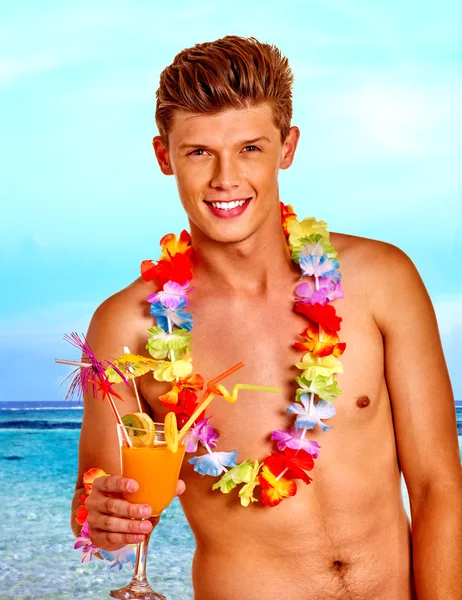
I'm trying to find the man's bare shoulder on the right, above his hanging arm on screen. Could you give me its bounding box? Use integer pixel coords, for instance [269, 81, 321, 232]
[331, 233, 429, 332]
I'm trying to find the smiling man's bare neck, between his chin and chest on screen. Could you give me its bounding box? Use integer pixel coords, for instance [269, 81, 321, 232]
[190, 213, 294, 296]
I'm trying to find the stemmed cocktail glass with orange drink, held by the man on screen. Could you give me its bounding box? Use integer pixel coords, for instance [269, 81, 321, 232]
[110, 423, 186, 600]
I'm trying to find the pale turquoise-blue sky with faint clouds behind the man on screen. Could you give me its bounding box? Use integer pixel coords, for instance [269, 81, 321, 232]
[0, 0, 462, 400]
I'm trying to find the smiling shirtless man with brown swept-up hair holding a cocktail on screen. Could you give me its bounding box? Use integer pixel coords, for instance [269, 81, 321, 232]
[73, 37, 462, 600]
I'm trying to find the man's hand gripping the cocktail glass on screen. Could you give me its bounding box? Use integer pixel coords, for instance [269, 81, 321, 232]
[85, 475, 186, 551]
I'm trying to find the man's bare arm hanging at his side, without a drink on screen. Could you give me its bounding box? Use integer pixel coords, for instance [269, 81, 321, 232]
[377, 245, 462, 600]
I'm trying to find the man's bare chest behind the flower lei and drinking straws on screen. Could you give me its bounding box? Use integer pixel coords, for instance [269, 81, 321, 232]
[142, 274, 383, 457]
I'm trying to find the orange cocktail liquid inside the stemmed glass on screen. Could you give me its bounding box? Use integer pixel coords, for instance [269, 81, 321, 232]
[121, 442, 186, 515]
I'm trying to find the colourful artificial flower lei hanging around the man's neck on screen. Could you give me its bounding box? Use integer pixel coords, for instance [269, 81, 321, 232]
[141, 203, 346, 506]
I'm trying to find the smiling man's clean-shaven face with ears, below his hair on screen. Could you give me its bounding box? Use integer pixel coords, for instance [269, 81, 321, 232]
[154, 104, 299, 242]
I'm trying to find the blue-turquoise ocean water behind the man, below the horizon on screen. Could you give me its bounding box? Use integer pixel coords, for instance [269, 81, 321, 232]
[0, 403, 462, 600]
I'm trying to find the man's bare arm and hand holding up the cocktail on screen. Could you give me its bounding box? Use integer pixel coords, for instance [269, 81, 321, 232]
[71, 283, 184, 550]
